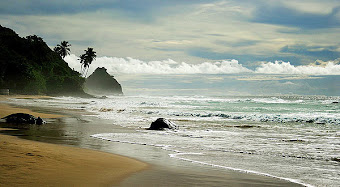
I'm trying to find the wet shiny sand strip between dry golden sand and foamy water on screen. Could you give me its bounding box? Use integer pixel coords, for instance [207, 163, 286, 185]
[0, 95, 301, 186]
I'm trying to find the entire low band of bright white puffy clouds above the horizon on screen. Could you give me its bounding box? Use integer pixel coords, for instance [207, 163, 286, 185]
[65, 54, 340, 76]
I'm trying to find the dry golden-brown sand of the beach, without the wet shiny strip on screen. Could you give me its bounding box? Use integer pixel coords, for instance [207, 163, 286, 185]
[0, 96, 148, 186]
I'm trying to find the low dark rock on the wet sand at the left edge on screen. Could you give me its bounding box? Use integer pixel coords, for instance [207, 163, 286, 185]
[2, 113, 46, 125]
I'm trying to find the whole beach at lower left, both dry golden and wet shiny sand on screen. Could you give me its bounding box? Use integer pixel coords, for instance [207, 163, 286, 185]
[0, 96, 300, 187]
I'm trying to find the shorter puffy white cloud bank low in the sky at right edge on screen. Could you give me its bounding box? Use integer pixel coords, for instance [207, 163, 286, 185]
[255, 61, 340, 75]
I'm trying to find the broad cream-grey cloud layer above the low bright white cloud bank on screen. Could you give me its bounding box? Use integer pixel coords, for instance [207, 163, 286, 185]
[0, 0, 340, 69]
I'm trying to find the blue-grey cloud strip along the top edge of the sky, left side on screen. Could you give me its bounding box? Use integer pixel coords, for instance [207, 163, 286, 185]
[0, 0, 207, 19]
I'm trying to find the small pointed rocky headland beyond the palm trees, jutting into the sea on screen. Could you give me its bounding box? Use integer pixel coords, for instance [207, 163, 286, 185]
[85, 68, 123, 95]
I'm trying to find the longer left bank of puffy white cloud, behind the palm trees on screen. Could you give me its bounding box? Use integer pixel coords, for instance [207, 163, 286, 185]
[65, 54, 252, 74]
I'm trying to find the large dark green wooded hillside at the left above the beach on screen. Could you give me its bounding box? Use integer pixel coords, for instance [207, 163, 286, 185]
[0, 25, 87, 96]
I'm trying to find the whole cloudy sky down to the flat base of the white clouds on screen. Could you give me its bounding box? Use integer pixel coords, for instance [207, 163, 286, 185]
[0, 0, 340, 95]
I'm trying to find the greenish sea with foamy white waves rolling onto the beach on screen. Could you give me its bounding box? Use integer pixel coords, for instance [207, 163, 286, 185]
[11, 95, 340, 186]
